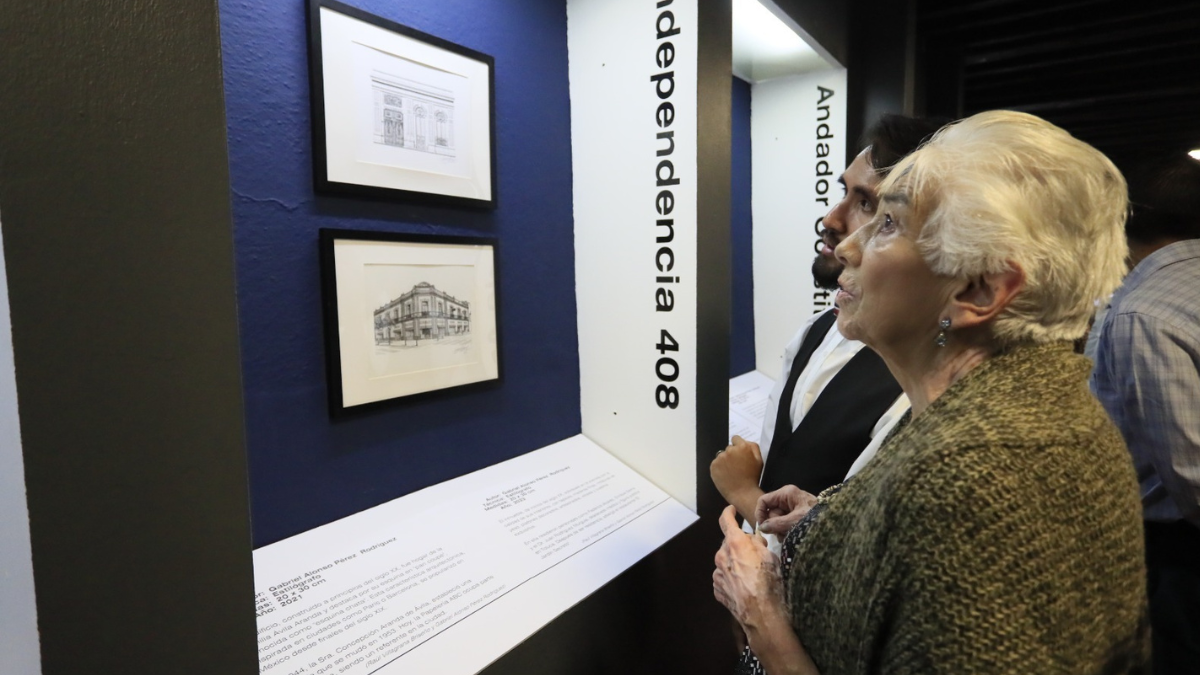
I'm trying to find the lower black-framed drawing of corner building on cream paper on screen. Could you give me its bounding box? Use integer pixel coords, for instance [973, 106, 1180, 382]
[320, 229, 500, 416]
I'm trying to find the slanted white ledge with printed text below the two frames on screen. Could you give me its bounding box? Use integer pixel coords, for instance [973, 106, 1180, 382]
[254, 436, 697, 675]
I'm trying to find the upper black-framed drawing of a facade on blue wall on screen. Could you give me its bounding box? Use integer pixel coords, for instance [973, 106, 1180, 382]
[308, 0, 496, 208]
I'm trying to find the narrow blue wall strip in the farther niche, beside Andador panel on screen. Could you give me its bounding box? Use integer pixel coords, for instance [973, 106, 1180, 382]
[730, 77, 755, 377]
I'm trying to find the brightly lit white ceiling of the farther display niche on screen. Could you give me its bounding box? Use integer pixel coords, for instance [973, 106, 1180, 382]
[733, 0, 833, 83]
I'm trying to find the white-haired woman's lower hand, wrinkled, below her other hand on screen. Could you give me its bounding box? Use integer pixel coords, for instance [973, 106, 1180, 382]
[713, 506, 784, 628]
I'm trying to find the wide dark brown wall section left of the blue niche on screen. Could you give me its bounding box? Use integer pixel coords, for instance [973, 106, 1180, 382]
[0, 0, 258, 675]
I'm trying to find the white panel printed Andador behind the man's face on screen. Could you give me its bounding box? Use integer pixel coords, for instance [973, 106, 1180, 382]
[750, 68, 853, 377]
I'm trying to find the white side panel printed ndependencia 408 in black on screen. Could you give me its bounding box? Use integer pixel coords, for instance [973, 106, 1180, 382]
[566, 0, 698, 509]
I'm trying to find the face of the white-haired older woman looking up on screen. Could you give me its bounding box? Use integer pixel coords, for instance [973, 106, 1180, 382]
[835, 185, 953, 357]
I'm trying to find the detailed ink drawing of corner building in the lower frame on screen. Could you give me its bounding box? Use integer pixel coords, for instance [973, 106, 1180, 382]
[374, 281, 470, 346]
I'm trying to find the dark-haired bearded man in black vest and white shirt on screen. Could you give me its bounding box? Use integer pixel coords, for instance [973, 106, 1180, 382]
[709, 115, 947, 521]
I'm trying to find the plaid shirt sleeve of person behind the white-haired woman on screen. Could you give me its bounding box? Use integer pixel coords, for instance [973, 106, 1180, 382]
[1092, 313, 1200, 526]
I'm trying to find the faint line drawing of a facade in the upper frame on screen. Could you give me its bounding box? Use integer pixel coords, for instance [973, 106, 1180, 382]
[371, 71, 455, 157]
